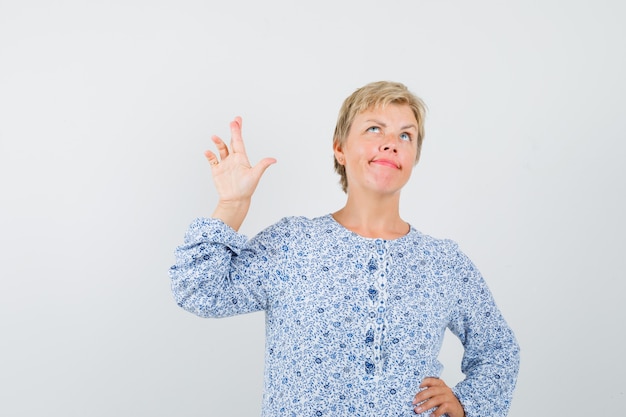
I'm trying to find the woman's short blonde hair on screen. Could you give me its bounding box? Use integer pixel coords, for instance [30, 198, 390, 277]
[333, 81, 426, 193]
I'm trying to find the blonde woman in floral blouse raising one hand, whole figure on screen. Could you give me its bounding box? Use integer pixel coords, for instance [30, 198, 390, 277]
[170, 82, 519, 417]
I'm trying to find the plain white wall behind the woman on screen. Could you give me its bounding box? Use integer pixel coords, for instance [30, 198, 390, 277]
[0, 0, 626, 417]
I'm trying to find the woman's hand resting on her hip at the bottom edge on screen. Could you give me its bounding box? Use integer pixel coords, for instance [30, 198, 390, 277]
[413, 378, 465, 417]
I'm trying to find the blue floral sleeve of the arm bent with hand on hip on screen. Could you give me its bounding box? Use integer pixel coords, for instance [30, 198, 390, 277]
[449, 245, 520, 417]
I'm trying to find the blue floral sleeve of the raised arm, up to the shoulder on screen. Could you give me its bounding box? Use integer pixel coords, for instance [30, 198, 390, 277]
[170, 217, 303, 317]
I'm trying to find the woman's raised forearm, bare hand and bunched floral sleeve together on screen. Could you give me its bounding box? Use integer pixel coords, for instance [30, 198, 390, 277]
[170, 117, 276, 317]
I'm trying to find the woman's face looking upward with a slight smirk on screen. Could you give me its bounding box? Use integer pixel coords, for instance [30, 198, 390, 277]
[334, 104, 418, 194]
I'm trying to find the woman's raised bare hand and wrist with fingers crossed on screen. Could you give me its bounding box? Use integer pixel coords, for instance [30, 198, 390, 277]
[204, 117, 276, 230]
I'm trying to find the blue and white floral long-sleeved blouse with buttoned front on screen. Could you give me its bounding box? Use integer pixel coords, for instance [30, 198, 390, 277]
[170, 215, 519, 417]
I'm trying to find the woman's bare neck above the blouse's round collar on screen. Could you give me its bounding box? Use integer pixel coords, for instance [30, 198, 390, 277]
[333, 188, 409, 239]
